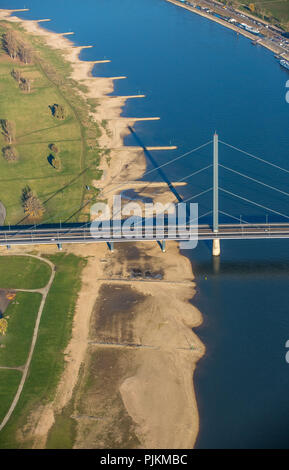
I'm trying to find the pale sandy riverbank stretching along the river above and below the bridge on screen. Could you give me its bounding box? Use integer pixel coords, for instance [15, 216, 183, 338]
[0, 7, 204, 448]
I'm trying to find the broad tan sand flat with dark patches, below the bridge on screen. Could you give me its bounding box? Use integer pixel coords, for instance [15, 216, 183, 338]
[71, 243, 204, 448]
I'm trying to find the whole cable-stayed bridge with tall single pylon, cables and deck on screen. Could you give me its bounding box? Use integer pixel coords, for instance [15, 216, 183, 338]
[0, 133, 289, 255]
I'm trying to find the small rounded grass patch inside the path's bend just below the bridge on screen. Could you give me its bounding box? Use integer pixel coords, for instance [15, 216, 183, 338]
[0, 256, 51, 289]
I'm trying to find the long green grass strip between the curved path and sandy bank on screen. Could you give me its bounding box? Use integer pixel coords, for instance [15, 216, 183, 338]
[0, 253, 86, 449]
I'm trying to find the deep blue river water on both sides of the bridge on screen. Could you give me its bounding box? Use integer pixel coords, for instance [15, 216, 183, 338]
[0, 0, 289, 448]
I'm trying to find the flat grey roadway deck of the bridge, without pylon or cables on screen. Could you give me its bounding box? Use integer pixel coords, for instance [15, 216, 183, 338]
[0, 223, 289, 246]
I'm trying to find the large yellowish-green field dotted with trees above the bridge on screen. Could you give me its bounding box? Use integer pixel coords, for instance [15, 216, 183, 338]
[0, 22, 100, 224]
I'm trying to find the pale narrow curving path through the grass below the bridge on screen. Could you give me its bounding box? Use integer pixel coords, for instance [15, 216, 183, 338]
[0, 254, 55, 431]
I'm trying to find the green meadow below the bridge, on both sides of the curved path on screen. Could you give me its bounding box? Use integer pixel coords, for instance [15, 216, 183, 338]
[0, 253, 86, 449]
